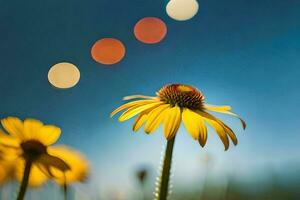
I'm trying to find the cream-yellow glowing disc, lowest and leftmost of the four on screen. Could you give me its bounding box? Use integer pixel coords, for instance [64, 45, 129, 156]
[48, 62, 80, 89]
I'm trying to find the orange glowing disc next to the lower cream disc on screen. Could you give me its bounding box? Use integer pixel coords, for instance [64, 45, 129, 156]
[91, 38, 125, 65]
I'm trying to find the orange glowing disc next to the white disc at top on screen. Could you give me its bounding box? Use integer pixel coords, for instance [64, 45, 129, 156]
[134, 17, 167, 44]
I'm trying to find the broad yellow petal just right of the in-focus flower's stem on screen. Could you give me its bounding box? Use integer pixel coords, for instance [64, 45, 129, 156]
[182, 108, 207, 147]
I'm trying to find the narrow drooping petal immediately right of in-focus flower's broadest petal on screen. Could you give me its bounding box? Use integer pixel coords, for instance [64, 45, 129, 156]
[198, 111, 229, 150]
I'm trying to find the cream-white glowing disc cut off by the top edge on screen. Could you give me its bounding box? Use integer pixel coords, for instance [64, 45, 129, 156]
[166, 0, 199, 21]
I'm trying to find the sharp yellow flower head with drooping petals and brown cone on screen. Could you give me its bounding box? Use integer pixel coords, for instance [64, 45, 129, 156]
[111, 84, 246, 150]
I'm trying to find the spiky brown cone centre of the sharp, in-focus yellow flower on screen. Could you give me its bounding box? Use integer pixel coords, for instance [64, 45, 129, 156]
[157, 84, 204, 109]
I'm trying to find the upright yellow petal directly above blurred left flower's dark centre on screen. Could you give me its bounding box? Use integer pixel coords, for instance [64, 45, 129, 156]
[24, 119, 44, 140]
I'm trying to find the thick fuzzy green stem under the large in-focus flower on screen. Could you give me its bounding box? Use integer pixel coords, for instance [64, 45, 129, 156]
[157, 136, 175, 200]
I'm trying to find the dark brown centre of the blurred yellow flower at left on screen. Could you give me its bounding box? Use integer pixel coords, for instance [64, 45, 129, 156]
[21, 140, 47, 160]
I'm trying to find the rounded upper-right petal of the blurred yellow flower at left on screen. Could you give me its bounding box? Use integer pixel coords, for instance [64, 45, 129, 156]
[36, 125, 61, 146]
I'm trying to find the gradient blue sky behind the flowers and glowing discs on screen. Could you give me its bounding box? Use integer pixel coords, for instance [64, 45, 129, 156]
[0, 0, 300, 198]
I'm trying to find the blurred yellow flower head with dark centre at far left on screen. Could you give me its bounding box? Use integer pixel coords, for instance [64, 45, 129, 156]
[0, 117, 70, 186]
